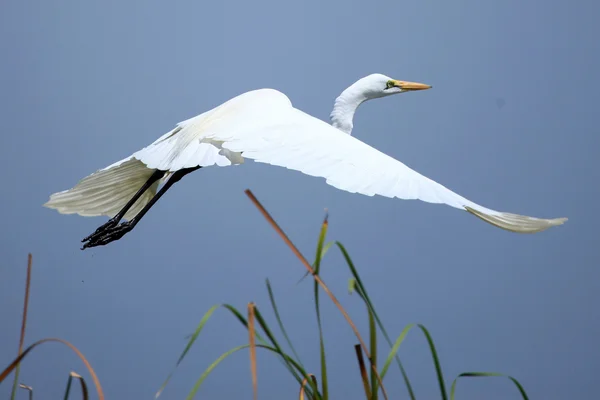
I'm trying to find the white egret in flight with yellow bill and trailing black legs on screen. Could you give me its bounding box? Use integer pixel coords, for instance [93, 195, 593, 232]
[44, 74, 567, 250]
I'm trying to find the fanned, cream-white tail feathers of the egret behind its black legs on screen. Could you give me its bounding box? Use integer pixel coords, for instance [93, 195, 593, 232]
[44, 158, 161, 220]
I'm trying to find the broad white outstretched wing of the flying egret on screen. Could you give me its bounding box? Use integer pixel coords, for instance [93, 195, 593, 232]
[134, 89, 567, 233]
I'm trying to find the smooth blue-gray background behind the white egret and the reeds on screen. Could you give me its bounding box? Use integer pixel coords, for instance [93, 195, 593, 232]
[0, 0, 600, 399]
